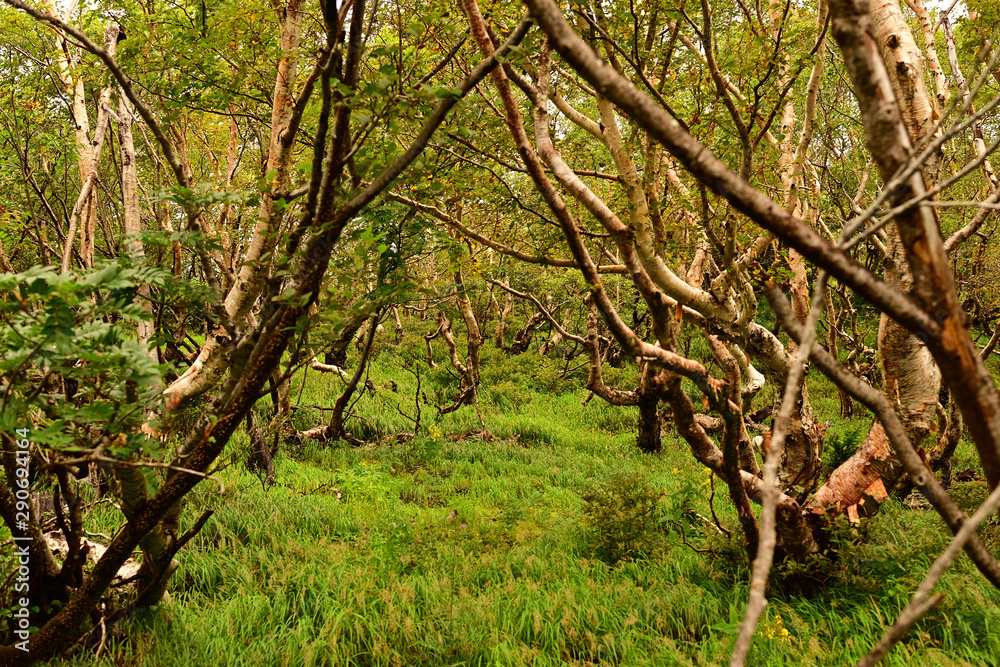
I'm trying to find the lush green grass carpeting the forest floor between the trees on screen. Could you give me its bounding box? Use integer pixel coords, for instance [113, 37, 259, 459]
[53, 326, 1000, 667]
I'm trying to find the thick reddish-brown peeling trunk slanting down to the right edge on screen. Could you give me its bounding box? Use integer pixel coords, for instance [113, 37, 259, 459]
[831, 0, 1000, 488]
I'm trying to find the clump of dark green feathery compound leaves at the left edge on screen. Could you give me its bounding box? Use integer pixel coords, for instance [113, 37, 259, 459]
[0, 262, 169, 458]
